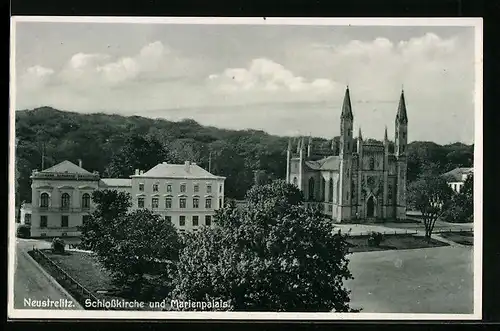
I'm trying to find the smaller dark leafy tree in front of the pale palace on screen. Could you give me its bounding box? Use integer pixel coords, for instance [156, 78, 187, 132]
[81, 190, 182, 301]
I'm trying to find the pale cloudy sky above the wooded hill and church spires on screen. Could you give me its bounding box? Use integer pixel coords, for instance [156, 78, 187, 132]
[15, 22, 474, 144]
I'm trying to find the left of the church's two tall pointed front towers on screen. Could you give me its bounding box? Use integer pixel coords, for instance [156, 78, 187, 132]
[337, 86, 354, 222]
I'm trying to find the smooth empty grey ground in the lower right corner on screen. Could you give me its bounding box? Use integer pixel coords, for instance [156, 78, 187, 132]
[346, 246, 474, 314]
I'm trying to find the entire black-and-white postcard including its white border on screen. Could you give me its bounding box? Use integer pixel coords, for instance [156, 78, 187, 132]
[8, 16, 483, 320]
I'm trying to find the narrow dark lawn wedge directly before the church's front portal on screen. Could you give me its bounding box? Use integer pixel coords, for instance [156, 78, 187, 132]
[347, 235, 448, 253]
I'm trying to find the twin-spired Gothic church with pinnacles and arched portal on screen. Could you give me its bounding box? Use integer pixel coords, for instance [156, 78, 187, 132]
[286, 87, 408, 222]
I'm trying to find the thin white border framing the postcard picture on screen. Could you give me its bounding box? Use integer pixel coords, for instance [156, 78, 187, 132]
[8, 16, 483, 320]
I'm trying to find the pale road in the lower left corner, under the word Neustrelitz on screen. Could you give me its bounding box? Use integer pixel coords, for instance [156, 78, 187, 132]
[14, 239, 83, 310]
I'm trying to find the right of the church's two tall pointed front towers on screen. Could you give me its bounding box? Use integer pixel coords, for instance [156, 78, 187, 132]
[394, 90, 408, 219]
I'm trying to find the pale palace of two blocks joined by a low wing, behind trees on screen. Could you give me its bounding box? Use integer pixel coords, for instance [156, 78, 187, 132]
[20, 161, 225, 237]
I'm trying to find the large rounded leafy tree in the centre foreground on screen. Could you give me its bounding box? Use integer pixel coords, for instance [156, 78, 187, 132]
[172, 181, 352, 312]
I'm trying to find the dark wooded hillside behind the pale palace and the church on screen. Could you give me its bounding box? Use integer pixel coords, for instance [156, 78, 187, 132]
[16, 107, 474, 204]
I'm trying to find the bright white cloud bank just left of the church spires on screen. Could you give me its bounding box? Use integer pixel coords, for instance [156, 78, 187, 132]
[208, 58, 335, 93]
